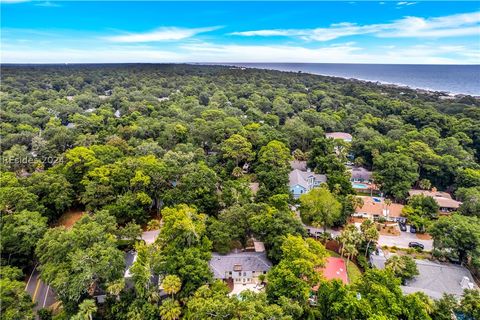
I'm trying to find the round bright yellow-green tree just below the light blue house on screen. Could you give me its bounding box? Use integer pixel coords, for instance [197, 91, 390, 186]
[300, 187, 342, 232]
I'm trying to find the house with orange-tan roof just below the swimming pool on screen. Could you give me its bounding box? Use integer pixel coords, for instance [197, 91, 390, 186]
[353, 196, 403, 219]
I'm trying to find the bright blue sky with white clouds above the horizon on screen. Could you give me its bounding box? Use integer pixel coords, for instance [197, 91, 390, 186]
[0, 0, 480, 64]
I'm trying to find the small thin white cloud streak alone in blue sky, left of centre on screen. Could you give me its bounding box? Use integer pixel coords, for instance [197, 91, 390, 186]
[104, 27, 220, 43]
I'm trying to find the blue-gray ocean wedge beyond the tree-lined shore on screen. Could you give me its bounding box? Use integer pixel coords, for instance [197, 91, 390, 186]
[229, 63, 480, 96]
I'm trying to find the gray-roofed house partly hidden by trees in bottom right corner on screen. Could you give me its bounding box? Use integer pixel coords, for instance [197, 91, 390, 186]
[370, 253, 477, 299]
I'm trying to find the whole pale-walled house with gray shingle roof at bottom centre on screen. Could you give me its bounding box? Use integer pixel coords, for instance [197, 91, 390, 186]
[209, 251, 272, 291]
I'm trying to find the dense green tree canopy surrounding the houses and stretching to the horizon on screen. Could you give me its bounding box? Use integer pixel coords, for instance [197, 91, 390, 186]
[0, 64, 480, 320]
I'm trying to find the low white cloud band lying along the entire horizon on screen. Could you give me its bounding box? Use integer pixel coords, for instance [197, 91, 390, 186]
[1, 42, 479, 64]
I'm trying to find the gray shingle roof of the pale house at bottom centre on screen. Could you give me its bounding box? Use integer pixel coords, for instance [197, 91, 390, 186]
[209, 252, 272, 279]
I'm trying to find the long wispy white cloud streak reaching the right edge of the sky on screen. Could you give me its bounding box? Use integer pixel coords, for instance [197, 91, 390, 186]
[231, 11, 480, 41]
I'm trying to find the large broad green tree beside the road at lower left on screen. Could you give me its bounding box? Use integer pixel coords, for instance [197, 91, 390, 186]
[35, 211, 124, 311]
